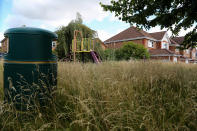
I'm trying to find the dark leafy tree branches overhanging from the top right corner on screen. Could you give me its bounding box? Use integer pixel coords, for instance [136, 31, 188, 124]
[101, 0, 197, 48]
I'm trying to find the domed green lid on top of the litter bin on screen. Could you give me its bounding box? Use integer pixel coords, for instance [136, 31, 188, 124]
[4, 27, 57, 39]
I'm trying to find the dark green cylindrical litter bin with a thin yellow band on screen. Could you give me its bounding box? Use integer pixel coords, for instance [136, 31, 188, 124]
[4, 27, 57, 110]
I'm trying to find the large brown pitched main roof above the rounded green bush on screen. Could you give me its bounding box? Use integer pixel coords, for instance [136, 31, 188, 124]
[104, 26, 155, 44]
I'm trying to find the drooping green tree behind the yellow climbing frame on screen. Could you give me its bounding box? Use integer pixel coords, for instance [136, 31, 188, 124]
[56, 13, 96, 59]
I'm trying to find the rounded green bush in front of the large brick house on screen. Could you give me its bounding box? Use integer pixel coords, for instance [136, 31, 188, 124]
[115, 42, 150, 60]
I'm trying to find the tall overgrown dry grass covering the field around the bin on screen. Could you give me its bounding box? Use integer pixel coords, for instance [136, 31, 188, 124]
[0, 62, 197, 131]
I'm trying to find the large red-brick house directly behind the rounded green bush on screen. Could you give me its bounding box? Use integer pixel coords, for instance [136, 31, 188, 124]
[104, 27, 195, 62]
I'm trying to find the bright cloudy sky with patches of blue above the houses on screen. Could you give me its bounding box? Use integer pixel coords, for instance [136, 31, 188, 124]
[0, 0, 195, 41]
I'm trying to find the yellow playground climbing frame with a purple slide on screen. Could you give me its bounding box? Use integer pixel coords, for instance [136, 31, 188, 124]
[72, 30, 101, 63]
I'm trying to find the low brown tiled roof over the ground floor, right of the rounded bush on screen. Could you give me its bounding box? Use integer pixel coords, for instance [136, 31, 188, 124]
[149, 49, 177, 56]
